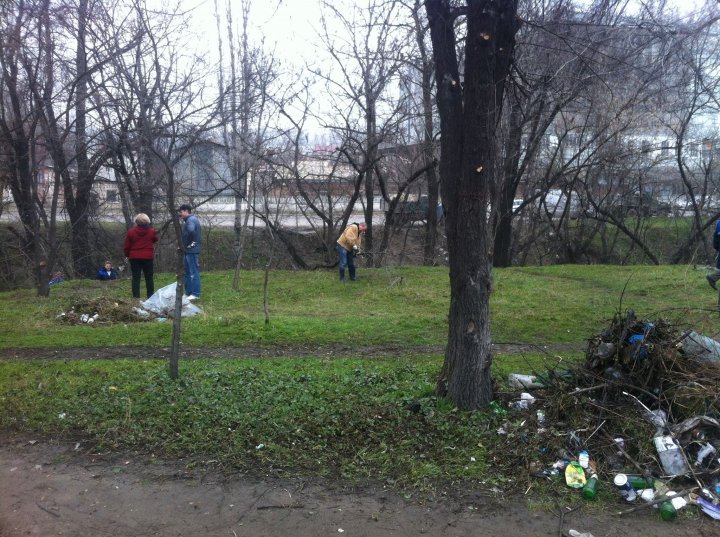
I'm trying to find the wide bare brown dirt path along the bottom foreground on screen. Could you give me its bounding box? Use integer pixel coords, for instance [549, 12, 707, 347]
[0, 437, 720, 537]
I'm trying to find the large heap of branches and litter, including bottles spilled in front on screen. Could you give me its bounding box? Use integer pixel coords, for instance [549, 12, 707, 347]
[495, 311, 720, 520]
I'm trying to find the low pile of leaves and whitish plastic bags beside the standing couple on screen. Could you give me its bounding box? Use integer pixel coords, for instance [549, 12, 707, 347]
[55, 283, 202, 325]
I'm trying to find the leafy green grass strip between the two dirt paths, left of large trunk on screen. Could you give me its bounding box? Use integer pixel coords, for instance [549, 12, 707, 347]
[0, 356, 512, 486]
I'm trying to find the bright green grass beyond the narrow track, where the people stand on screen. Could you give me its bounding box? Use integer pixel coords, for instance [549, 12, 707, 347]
[0, 265, 716, 348]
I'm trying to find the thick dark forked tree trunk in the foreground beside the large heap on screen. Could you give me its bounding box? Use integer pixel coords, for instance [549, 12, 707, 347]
[425, 0, 518, 409]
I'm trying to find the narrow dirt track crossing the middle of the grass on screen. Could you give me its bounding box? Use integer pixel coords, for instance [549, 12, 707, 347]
[0, 343, 585, 361]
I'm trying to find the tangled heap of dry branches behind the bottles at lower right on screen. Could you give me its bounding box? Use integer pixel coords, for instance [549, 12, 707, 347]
[494, 311, 720, 489]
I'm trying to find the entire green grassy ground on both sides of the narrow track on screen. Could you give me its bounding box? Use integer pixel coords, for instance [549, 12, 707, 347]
[0, 266, 718, 494]
